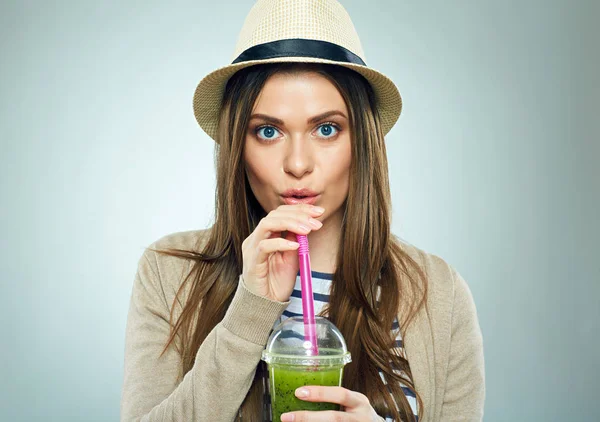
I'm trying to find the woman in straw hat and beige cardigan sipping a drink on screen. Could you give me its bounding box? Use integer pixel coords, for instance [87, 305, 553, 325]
[121, 0, 485, 421]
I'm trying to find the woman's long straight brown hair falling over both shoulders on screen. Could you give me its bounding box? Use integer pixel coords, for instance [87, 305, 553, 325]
[156, 63, 427, 421]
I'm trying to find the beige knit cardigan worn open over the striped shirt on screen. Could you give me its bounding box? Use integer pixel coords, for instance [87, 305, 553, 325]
[121, 231, 485, 422]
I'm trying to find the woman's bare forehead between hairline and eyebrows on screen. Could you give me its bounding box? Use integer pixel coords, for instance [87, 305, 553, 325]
[254, 71, 347, 114]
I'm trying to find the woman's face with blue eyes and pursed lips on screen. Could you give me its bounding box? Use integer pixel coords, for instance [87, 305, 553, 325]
[244, 72, 351, 226]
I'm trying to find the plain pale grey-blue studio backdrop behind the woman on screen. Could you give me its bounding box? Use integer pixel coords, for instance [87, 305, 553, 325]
[0, 0, 600, 422]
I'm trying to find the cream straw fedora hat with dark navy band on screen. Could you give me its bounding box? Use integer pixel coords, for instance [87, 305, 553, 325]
[194, 0, 402, 142]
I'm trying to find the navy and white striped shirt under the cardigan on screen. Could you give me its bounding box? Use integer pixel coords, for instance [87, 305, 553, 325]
[268, 271, 418, 421]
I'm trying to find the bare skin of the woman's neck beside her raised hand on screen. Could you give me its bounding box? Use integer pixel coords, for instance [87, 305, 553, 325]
[308, 211, 342, 274]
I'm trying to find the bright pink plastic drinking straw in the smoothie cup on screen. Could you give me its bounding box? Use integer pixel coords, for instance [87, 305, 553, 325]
[296, 234, 319, 356]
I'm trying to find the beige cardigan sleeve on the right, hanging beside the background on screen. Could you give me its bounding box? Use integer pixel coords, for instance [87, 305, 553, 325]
[440, 270, 485, 422]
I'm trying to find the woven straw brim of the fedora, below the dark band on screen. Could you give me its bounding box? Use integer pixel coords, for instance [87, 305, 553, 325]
[193, 57, 402, 142]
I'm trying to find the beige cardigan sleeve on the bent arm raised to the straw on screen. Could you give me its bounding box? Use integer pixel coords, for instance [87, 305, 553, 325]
[121, 251, 289, 422]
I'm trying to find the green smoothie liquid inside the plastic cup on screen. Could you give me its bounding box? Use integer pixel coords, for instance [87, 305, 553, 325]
[269, 364, 344, 422]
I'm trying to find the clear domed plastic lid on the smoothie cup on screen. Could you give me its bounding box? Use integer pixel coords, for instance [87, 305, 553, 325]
[262, 316, 352, 366]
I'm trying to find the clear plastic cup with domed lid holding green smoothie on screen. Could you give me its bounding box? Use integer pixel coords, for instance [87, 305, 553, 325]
[262, 317, 352, 421]
